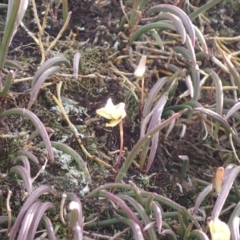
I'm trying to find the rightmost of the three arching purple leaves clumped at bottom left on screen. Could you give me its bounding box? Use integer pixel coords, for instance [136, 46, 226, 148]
[28, 202, 55, 239]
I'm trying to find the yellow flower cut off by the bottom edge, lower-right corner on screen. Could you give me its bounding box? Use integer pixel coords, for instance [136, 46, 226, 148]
[209, 218, 231, 240]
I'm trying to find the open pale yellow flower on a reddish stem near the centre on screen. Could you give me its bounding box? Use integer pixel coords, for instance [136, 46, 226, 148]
[96, 98, 127, 127]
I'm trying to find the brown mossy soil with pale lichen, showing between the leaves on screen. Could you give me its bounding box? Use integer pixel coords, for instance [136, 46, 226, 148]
[0, 0, 240, 239]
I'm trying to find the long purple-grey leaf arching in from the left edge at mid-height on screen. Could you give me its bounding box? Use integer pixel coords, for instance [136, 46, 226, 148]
[0, 108, 54, 161]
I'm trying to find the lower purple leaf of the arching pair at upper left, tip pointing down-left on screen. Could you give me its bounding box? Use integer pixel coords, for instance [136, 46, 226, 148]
[27, 66, 61, 109]
